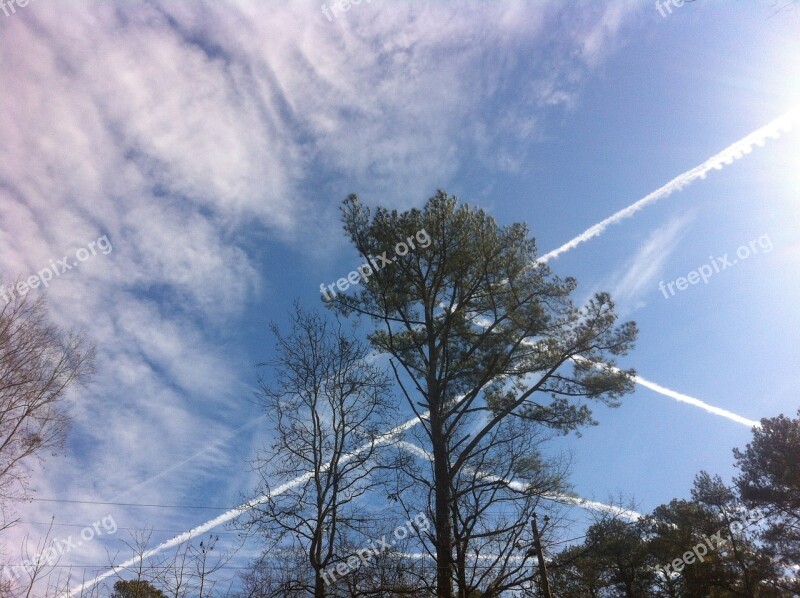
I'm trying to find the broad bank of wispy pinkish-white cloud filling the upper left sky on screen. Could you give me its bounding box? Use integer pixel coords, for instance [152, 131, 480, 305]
[0, 1, 630, 559]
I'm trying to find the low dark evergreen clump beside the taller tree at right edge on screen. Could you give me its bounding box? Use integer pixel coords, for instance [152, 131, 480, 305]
[552, 472, 798, 598]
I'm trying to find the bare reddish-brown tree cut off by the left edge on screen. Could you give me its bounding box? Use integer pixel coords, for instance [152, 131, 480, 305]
[0, 295, 94, 530]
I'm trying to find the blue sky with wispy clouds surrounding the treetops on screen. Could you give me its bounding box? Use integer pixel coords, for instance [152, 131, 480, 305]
[0, 0, 800, 596]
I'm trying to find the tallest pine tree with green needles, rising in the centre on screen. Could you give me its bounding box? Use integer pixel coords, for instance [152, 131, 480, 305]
[331, 191, 636, 598]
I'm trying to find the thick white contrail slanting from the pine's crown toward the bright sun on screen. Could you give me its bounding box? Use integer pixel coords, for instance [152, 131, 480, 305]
[537, 108, 800, 263]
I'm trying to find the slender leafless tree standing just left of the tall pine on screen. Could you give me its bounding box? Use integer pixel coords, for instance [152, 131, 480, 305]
[246, 304, 392, 598]
